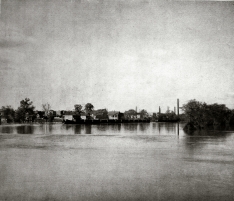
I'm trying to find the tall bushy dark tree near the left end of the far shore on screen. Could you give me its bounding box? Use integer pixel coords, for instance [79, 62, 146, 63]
[16, 98, 35, 122]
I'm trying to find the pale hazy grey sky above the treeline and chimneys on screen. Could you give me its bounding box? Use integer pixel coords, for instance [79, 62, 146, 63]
[0, 0, 234, 112]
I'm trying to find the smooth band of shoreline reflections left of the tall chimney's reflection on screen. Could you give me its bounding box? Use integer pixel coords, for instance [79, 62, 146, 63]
[0, 122, 177, 135]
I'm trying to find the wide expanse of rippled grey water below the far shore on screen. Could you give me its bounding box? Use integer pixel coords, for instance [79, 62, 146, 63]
[0, 123, 234, 201]
